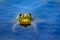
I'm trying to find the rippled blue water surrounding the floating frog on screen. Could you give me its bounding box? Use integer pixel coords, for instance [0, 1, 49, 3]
[0, 0, 60, 40]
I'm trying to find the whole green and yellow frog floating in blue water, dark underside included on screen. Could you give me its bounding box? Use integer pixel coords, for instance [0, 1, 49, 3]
[18, 13, 33, 27]
